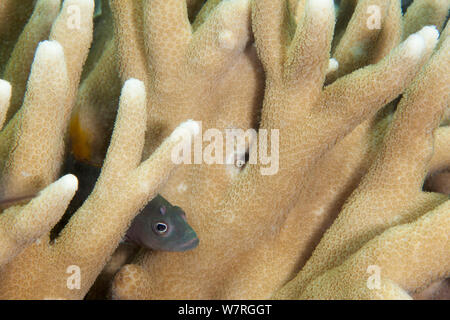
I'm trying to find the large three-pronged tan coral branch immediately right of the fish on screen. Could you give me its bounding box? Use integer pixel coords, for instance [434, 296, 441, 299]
[109, 1, 436, 298]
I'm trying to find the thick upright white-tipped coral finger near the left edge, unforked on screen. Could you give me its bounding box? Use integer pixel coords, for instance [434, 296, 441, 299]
[1, 41, 70, 197]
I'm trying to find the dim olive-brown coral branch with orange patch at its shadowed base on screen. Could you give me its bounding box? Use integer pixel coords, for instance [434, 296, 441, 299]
[71, 0, 210, 159]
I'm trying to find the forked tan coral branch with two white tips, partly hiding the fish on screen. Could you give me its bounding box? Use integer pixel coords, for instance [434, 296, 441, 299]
[0, 80, 198, 299]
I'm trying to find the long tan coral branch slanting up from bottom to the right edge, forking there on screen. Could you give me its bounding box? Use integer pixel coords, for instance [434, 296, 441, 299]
[277, 28, 450, 297]
